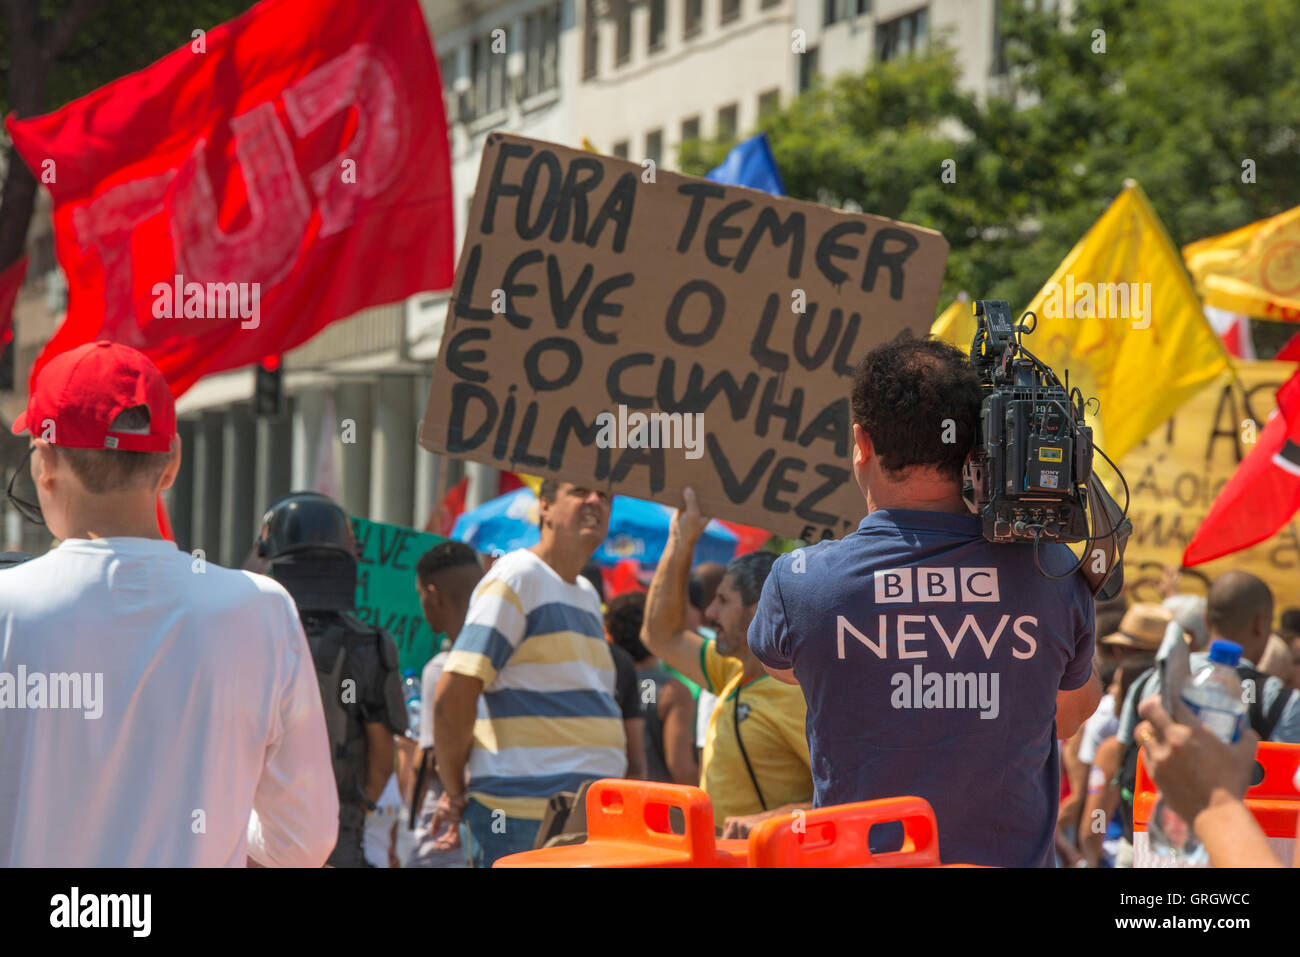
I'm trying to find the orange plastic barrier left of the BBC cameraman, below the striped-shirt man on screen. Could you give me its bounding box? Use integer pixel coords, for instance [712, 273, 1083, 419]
[493, 779, 748, 867]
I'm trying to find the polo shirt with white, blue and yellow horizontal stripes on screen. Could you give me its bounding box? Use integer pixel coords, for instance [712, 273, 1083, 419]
[446, 549, 628, 820]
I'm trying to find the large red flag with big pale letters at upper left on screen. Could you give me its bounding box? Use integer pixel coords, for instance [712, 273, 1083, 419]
[7, 0, 454, 395]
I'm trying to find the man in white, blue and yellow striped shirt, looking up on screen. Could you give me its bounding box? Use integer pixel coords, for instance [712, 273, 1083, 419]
[433, 480, 628, 867]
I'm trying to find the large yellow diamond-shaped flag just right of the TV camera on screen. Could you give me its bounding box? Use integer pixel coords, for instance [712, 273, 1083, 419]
[1022, 181, 1229, 462]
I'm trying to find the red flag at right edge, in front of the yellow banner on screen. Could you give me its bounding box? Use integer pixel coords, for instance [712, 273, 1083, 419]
[1183, 371, 1300, 567]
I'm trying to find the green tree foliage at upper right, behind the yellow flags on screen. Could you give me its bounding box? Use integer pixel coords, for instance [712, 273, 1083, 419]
[681, 0, 1300, 354]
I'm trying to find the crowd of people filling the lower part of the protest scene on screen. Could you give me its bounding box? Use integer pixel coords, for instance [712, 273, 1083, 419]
[0, 338, 1300, 867]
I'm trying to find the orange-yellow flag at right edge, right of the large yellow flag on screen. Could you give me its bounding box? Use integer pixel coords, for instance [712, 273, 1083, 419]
[1183, 205, 1300, 321]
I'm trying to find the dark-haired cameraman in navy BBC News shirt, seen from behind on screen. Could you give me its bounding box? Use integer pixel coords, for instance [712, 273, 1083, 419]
[749, 338, 1101, 867]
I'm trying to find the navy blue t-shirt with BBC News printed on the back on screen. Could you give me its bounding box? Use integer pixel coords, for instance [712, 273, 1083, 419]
[749, 510, 1093, 867]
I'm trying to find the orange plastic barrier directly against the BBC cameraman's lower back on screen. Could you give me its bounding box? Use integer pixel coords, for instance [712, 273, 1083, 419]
[749, 797, 939, 867]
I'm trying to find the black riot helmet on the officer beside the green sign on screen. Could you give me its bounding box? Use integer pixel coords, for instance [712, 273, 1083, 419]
[256, 492, 358, 611]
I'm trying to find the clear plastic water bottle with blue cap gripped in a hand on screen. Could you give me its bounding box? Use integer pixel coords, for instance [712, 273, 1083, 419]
[1147, 640, 1247, 865]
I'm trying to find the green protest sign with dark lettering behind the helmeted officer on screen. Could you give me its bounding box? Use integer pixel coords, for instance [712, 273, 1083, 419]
[352, 518, 447, 674]
